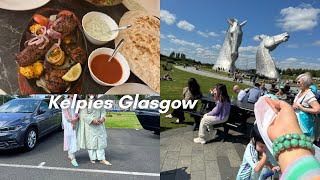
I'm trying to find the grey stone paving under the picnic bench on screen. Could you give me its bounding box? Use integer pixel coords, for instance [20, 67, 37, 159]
[160, 118, 253, 180]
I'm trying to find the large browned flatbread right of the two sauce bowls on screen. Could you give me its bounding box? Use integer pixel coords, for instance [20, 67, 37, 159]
[115, 11, 160, 93]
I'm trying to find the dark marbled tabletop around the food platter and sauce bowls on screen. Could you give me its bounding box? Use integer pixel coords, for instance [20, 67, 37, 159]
[0, 0, 144, 94]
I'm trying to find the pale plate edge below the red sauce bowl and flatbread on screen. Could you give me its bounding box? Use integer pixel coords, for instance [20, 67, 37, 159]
[106, 83, 158, 95]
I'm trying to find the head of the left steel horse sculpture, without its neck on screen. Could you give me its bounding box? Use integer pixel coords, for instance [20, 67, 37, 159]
[227, 18, 247, 61]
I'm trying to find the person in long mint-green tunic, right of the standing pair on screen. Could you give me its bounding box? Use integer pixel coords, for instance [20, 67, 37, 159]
[78, 95, 111, 166]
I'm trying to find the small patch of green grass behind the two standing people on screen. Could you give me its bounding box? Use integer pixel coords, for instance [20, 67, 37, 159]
[105, 112, 142, 129]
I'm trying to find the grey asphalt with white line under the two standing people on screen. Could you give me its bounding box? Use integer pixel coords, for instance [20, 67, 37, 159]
[0, 129, 160, 180]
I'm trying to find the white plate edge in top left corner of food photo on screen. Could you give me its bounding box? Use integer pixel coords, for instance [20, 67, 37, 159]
[0, 0, 50, 11]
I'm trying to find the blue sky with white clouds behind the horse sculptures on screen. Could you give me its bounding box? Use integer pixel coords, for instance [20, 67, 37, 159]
[160, 0, 320, 69]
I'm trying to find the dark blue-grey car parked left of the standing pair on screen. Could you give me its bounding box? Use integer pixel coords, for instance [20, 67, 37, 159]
[0, 98, 62, 150]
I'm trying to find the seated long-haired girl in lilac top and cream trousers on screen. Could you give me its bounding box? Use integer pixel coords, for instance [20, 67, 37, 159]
[193, 84, 231, 144]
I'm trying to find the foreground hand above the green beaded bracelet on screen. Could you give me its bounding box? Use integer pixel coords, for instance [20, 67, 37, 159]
[265, 98, 302, 141]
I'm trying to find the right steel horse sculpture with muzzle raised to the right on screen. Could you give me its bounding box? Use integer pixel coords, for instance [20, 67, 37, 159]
[256, 33, 290, 79]
